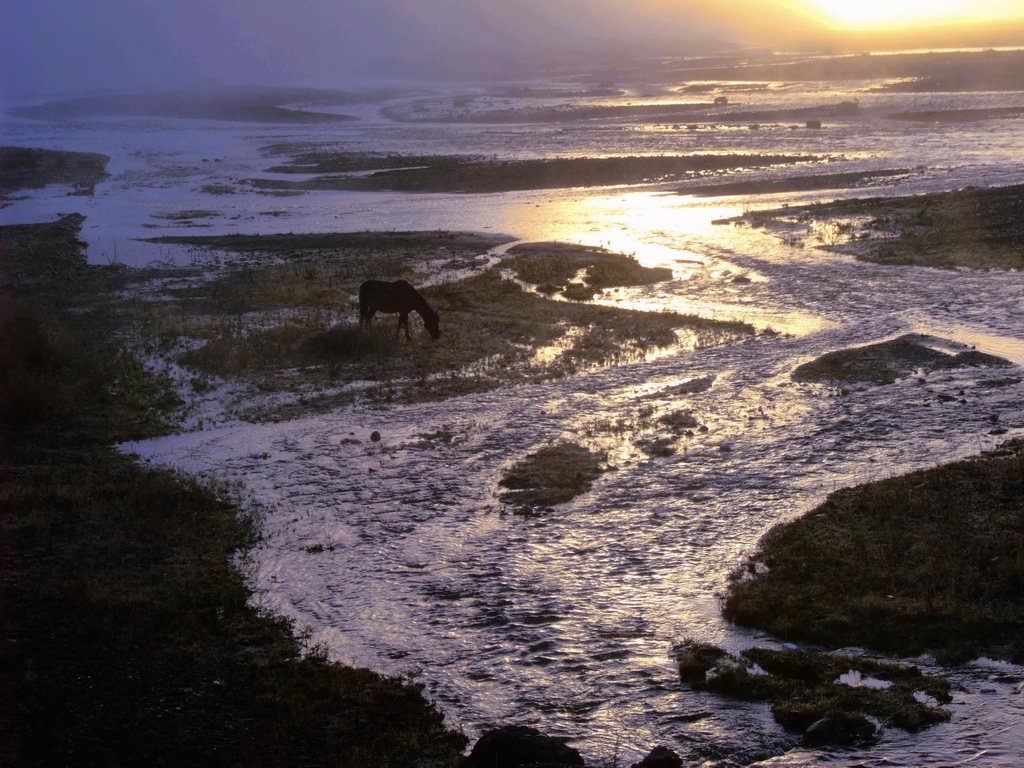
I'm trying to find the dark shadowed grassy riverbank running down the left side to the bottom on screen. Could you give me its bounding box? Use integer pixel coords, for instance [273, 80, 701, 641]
[0, 217, 465, 768]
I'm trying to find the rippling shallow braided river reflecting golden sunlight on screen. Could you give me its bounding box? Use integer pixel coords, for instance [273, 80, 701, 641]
[0, 75, 1024, 766]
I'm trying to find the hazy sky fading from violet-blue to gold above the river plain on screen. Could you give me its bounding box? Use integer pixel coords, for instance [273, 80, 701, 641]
[6, 0, 1024, 94]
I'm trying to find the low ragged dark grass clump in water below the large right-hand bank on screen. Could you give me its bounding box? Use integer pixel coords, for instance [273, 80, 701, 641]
[676, 640, 951, 731]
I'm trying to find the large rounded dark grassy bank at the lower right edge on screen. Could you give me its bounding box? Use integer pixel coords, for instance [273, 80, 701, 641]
[724, 440, 1024, 662]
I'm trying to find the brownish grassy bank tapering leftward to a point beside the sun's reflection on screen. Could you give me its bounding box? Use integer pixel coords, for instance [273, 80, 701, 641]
[716, 185, 1024, 269]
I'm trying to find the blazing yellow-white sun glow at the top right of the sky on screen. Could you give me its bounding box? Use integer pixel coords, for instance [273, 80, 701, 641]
[810, 0, 1022, 29]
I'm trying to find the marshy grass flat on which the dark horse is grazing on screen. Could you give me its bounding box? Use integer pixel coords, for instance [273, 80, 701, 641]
[123, 231, 754, 420]
